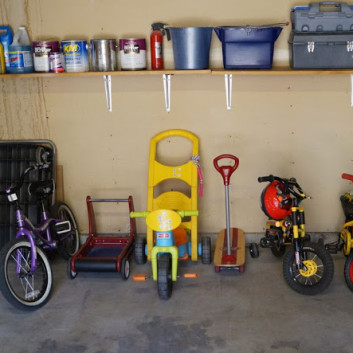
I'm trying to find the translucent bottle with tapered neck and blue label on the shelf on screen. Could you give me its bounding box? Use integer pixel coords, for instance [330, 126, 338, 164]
[9, 27, 34, 74]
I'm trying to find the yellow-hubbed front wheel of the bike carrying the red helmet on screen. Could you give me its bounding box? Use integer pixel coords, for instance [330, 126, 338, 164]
[283, 242, 334, 295]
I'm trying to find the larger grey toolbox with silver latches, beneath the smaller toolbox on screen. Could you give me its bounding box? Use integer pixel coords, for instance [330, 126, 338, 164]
[289, 31, 353, 69]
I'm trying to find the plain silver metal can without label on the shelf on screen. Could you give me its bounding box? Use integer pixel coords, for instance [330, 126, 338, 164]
[91, 39, 118, 71]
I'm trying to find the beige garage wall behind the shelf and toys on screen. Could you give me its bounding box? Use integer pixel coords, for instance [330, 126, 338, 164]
[0, 0, 353, 232]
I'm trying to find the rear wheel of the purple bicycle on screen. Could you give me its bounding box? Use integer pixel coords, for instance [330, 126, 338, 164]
[51, 202, 80, 260]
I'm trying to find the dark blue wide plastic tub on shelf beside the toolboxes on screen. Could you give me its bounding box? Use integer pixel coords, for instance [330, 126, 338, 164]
[214, 26, 282, 69]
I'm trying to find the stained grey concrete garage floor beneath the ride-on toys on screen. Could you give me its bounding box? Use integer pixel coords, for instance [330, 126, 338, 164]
[0, 245, 353, 353]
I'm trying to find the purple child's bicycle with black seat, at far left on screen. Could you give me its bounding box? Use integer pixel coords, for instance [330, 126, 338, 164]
[0, 163, 80, 310]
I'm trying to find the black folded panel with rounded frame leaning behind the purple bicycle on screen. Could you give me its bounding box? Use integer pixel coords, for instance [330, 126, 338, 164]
[0, 140, 56, 249]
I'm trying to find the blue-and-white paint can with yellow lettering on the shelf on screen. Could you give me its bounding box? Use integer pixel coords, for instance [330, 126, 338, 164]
[61, 40, 89, 72]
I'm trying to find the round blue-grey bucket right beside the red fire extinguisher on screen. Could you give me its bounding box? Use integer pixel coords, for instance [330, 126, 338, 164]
[166, 27, 213, 70]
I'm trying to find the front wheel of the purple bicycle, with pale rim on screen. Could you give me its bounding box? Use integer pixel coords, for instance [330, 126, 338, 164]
[0, 239, 53, 310]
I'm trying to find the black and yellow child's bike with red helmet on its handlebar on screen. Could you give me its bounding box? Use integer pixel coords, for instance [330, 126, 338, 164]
[258, 175, 334, 295]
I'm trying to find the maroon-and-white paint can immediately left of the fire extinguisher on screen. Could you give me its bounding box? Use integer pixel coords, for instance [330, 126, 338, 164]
[119, 39, 146, 70]
